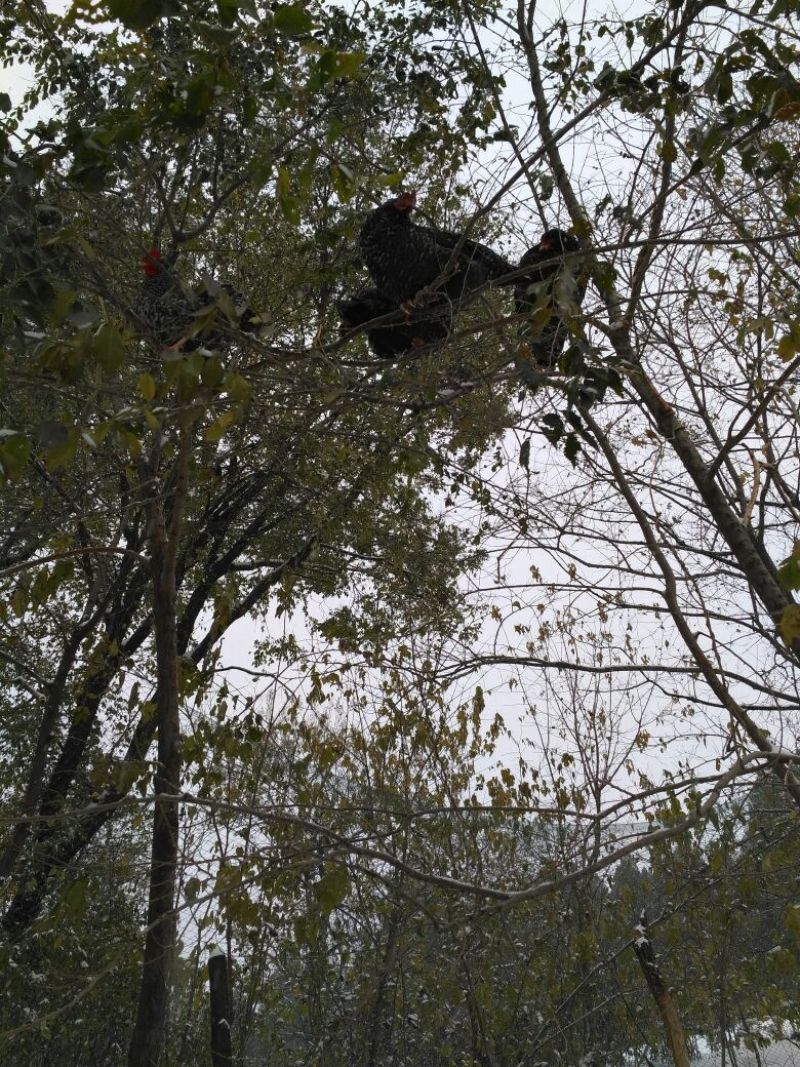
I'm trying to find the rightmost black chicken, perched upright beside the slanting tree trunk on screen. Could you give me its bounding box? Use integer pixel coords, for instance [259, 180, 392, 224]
[514, 229, 586, 368]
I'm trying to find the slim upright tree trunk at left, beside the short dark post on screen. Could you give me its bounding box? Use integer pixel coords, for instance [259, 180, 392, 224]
[128, 434, 188, 1067]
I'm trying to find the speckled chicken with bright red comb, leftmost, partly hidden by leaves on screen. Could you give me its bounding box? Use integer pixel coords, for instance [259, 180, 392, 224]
[138, 245, 259, 352]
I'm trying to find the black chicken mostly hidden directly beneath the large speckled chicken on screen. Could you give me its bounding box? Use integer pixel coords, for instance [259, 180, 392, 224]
[336, 289, 451, 360]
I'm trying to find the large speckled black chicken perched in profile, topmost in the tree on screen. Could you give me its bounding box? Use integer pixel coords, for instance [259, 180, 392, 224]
[358, 191, 512, 305]
